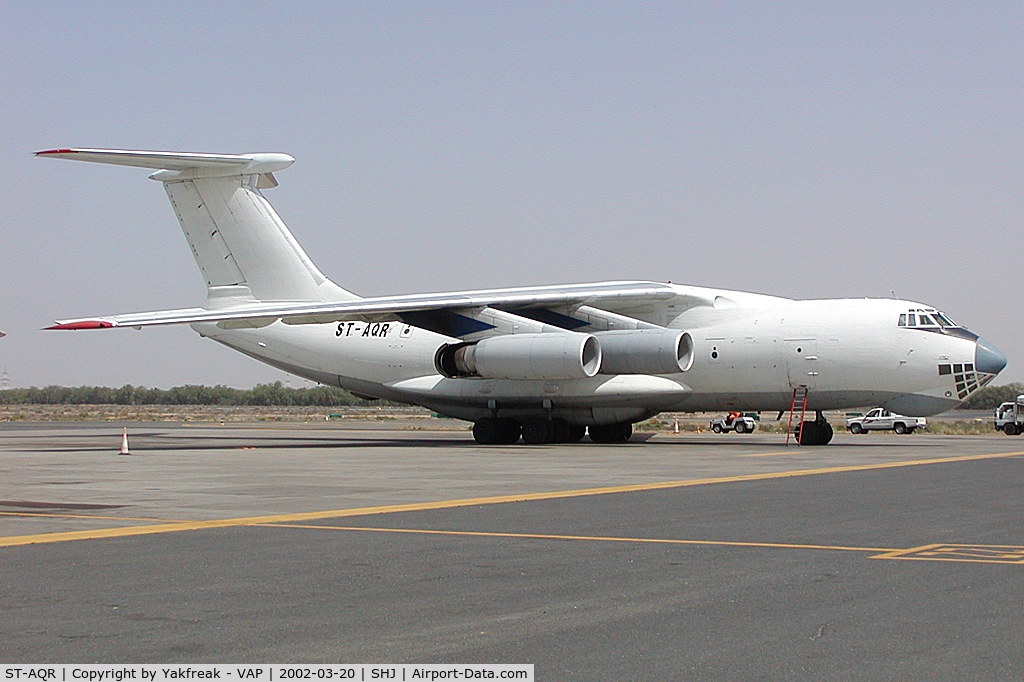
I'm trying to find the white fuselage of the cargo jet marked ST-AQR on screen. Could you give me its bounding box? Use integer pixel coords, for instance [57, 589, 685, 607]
[194, 287, 1001, 423]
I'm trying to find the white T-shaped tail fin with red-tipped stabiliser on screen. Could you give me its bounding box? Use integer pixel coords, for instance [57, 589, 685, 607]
[36, 150, 358, 307]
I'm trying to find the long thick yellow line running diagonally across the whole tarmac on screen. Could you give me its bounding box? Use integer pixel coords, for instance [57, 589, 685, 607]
[0, 452, 1024, 547]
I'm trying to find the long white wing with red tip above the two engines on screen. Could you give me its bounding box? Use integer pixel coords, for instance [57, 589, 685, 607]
[46, 282, 692, 330]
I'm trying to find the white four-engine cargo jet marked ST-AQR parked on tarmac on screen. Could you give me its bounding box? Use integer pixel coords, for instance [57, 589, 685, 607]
[37, 148, 1007, 444]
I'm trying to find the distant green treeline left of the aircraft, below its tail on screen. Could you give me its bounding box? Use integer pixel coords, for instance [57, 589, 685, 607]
[0, 381, 387, 408]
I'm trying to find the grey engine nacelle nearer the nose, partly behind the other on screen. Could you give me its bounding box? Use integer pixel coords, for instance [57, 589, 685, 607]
[594, 329, 693, 374]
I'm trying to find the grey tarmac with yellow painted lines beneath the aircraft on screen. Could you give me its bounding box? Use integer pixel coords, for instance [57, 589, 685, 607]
[0, 424, 1024, 680]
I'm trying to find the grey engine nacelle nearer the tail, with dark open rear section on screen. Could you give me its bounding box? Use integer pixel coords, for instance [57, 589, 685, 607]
[434, 332, 601, 379]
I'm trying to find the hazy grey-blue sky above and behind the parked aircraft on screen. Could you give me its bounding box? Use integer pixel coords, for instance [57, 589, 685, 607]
[0, 0, 1024, 387]
